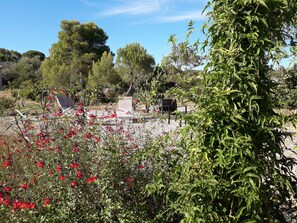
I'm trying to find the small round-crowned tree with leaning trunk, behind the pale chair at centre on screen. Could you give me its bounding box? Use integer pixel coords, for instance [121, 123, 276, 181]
[116, 43, 155, 95]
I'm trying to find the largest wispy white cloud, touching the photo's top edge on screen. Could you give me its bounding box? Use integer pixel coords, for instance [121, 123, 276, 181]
[101, 0, 167, 16]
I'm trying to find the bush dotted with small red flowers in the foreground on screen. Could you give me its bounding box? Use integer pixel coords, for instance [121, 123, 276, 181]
[0, 105, 178, 222]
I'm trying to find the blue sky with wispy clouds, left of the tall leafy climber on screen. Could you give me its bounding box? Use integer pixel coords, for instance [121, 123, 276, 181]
[0, 0, 207, 63]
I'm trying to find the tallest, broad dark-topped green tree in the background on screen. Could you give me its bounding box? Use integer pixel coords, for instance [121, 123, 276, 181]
[41, 20, 109, 87]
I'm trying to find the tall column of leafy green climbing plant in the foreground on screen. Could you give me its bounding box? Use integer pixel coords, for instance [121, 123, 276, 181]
[149, 0, 297, 222]
